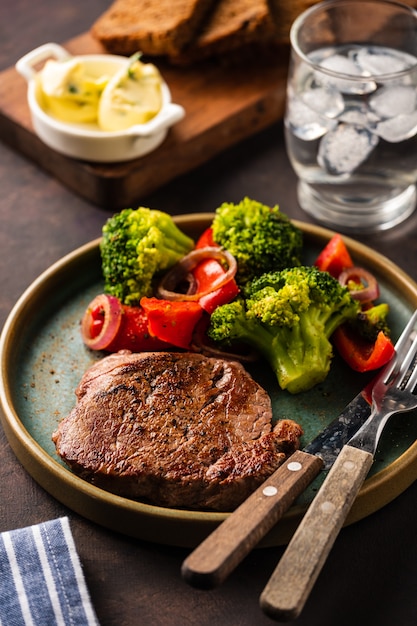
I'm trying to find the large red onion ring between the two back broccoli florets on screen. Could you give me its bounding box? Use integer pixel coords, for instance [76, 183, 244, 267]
[157, 246, 237, 301]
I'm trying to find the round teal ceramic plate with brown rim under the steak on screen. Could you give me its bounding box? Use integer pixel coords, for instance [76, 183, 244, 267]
[0, 214, 417, 547]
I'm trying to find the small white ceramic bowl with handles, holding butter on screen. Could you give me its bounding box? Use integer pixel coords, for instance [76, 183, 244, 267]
[16, 43, 185, 163]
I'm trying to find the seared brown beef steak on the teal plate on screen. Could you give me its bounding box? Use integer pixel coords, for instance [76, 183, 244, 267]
[52, 352, 302, 511]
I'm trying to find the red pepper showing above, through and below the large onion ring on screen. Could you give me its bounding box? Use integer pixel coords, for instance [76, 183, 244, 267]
[193, 227, 239, 314]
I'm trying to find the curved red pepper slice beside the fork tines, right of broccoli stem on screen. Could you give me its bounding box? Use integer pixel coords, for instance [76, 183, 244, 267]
[332, 324, 395, 372]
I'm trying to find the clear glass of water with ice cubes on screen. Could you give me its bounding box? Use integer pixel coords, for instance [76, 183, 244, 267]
[284, 0, 417, 233]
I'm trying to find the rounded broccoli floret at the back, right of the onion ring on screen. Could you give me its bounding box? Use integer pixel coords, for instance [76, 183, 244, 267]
[212, 198, 303, 286]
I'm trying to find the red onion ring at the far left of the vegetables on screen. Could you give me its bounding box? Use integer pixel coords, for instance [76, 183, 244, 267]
[81, 294, 123, 350]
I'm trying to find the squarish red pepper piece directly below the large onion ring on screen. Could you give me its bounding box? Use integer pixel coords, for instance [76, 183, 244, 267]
[140, 298, 203, 350]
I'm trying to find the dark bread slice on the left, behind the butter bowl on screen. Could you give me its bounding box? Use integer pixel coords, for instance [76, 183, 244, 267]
[90, 0, 217, 56]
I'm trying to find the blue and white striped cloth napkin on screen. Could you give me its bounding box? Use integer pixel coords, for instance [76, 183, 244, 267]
[0, 517, 98, 626]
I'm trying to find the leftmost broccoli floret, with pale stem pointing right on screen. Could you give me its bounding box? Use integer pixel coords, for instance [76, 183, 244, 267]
[100, 207, 194, 305]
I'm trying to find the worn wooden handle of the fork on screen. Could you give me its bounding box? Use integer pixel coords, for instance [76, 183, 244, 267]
[260, 445, 373, 621]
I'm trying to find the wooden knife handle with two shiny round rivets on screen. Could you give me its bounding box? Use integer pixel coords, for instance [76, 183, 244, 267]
[181, 450, 323, 589]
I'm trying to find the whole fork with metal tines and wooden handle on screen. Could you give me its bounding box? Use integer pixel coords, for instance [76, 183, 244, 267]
[260, 311, 417, 621]
